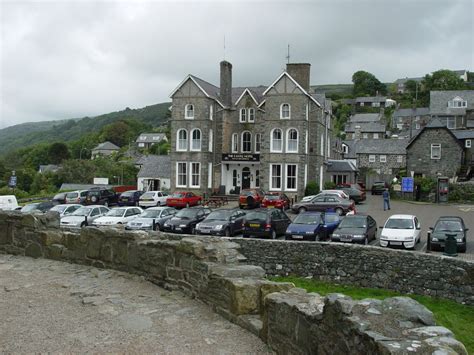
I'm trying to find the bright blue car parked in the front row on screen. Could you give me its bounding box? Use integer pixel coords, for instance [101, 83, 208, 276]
[285, 212, 341, 241]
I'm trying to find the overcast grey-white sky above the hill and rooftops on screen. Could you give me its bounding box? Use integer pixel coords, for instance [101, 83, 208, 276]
[0, 0, 474, 128]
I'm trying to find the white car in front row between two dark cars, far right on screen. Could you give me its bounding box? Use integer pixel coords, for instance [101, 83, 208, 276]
[380, 214, 421, 249]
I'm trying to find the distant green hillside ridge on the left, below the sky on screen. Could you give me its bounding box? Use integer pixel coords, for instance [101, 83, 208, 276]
[0, 102, 171, 155]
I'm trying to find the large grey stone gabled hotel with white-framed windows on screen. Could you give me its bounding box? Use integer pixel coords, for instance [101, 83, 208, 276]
[170, 61, 336, 198]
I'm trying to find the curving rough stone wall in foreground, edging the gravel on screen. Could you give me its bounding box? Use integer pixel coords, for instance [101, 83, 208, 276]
[0, 212, 467, 354]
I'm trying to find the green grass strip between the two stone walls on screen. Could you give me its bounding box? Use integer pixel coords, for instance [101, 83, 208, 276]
[272, 276, 474, 354]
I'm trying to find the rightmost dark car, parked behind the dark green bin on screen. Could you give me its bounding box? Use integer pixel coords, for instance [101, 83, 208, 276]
[428, 216, 469, 253]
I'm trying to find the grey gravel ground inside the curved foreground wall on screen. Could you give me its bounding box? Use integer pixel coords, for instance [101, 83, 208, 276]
[0, 254, 271, 354]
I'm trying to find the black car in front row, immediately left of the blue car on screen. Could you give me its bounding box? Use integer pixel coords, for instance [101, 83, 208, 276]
[242, 208, 291, 239]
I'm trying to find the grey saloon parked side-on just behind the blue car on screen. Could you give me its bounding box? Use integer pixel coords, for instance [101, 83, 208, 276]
[291, 194, 355, 216]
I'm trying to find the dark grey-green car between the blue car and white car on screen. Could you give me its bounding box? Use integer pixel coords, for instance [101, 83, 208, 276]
[331, 214, 377, 244]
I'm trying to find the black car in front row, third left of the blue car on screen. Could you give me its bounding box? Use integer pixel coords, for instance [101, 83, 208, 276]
[163, 206, 211, 234]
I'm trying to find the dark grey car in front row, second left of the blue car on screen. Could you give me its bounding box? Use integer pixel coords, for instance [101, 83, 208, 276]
[196, 208, 245, 237]
